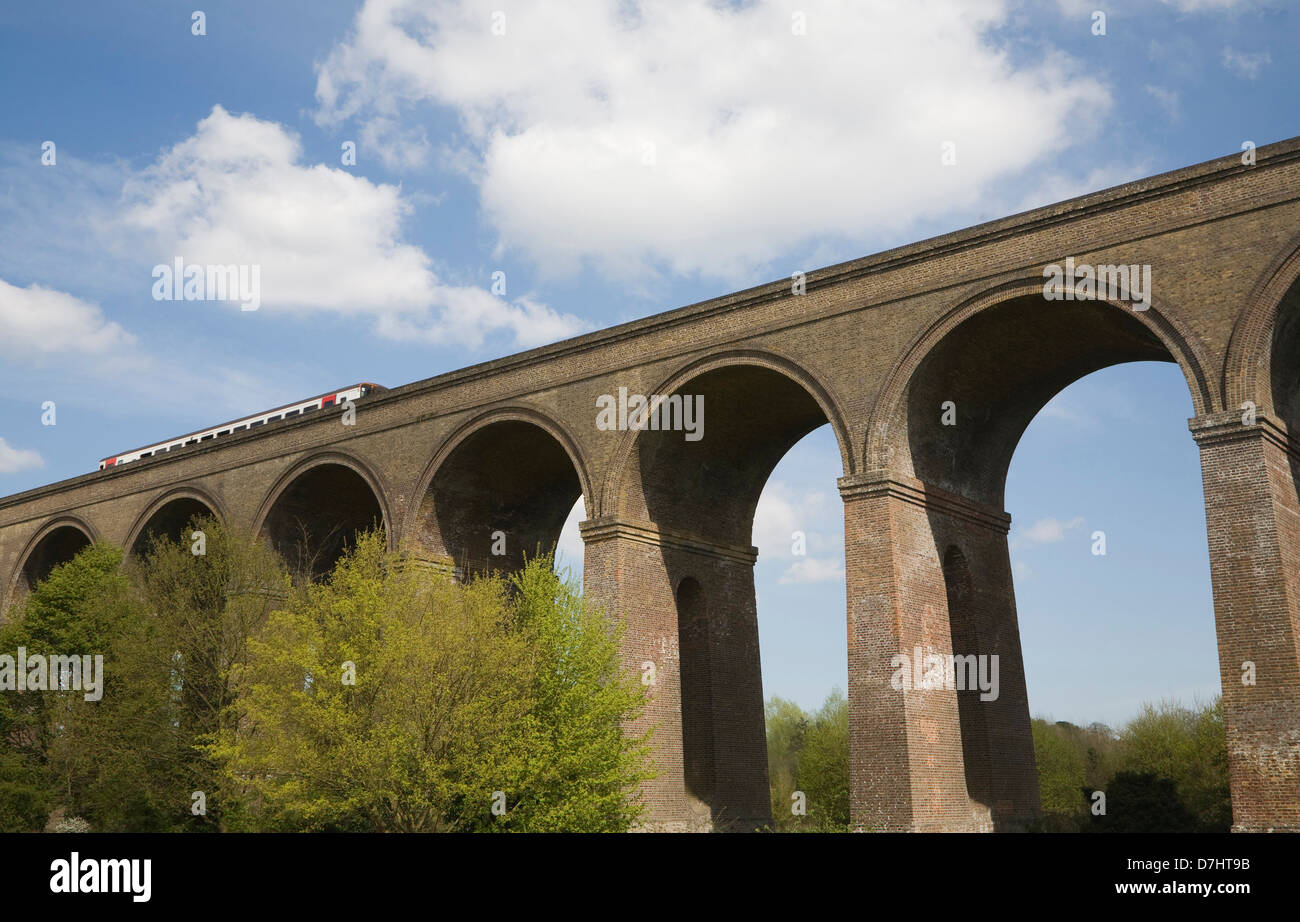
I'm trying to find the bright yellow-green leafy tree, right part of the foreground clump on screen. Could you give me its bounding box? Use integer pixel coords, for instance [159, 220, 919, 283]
[208, 534, 660, 832]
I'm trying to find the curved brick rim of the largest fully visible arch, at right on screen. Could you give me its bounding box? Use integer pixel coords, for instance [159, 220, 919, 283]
[862, 276, 1222, 499]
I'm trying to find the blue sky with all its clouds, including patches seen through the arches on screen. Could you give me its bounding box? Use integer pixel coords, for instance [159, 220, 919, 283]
[0, 0, 1300, 723]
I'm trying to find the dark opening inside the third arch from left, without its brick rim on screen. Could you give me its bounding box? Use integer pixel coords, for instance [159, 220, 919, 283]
[261, 462, 386, 581]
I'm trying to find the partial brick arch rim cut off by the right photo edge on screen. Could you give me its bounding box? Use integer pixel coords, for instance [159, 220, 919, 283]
[1222, 228, 1300, 412]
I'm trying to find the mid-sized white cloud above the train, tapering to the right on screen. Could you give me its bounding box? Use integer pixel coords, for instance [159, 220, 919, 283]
[114, 105, 582, 346]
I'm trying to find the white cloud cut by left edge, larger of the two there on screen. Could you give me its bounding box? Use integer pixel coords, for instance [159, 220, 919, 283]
[0, 278, 135, 358]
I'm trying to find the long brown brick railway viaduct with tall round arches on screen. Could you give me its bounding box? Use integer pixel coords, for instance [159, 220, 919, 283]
[0, 139, 1300, 831]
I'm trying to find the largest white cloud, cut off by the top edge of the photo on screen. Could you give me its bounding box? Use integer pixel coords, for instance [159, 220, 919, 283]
[317, 0, 1110, 278]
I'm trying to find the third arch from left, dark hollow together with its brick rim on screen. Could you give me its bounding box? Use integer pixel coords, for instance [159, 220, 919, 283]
[254, 451, 395, 580]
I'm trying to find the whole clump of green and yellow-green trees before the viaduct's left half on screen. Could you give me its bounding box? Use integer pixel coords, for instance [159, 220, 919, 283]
[0, 520, 647, 831]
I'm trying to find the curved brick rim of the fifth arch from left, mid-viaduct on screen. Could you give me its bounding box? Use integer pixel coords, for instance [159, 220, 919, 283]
[601, 349, 857, 515]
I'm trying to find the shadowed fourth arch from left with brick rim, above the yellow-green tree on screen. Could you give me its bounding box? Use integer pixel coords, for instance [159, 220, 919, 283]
[407, 404, 593, 576]
